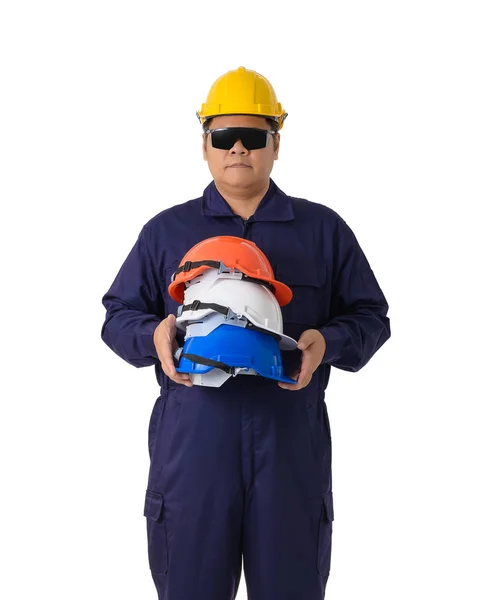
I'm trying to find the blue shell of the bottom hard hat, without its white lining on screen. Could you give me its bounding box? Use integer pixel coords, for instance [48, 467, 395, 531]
[176, 325, 296, 383]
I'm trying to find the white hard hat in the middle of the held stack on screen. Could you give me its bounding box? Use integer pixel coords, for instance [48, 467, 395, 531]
[176, 269, 297, 350]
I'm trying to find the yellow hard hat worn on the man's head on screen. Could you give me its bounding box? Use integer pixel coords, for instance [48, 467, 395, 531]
[196, 67, 288, 129]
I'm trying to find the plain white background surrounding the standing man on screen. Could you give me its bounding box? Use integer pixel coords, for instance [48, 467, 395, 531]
[0, 0, 491, 600]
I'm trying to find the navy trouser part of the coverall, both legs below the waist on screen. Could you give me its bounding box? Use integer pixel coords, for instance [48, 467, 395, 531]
[144, 376, 333, 600]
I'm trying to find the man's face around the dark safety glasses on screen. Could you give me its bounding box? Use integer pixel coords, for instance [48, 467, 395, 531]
[203, 115, 280, 188]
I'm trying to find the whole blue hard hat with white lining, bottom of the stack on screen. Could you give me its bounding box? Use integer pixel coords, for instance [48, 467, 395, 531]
[176, 324, 296, 387]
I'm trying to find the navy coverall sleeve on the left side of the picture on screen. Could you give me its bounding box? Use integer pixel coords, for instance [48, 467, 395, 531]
[101, 227, 165, 367]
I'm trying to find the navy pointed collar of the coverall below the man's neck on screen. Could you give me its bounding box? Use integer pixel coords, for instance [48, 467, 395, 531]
[202, 178, 295, 221]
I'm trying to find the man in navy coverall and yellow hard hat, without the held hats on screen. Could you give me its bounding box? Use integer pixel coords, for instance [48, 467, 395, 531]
[102, 67, 390, 600]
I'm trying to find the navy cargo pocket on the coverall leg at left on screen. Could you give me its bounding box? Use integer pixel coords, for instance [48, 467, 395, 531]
[143, 490, 169, 573]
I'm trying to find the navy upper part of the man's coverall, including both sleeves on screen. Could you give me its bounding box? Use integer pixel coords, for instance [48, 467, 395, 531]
[101, 179, 390, 387]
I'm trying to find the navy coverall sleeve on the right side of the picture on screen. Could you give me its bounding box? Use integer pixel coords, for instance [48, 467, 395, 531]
[319, 223, 391, 372]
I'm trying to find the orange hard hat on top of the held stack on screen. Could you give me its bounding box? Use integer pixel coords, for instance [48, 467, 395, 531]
[168, 235, 293, 306]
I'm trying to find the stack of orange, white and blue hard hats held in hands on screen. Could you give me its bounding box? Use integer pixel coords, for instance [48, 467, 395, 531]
[169, 236, 297, 387]
